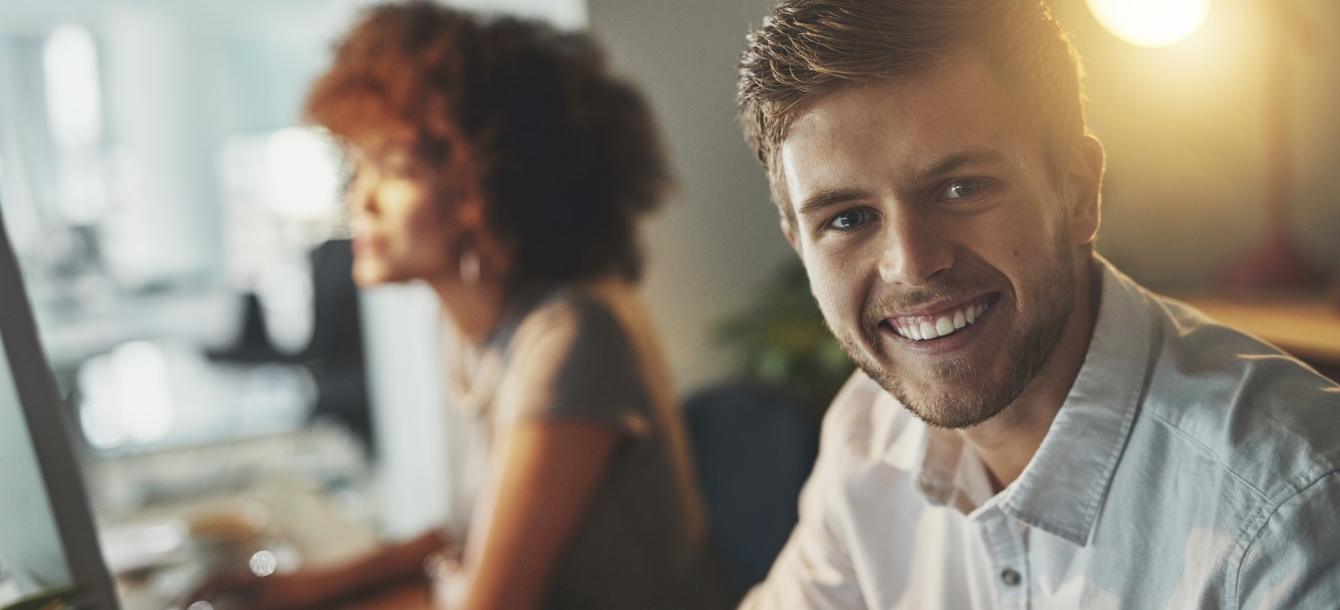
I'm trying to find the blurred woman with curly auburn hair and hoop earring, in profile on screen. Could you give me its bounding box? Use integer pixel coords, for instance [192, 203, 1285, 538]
[184, 1, 732, 610]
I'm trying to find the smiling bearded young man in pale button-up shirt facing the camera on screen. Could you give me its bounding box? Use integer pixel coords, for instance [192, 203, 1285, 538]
[740, 0, 1340, 609]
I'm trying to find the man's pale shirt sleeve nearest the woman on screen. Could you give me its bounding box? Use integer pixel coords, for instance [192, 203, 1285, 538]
[740, 373, 868, 610]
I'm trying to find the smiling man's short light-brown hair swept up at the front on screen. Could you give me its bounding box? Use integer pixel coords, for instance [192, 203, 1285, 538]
[737, 0, 1085, 220]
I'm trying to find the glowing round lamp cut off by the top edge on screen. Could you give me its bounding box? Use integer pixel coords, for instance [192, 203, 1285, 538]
[1085, 0, 1210, 47]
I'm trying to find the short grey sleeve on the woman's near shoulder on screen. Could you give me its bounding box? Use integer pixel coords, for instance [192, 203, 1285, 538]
[498, 294, 651, 436]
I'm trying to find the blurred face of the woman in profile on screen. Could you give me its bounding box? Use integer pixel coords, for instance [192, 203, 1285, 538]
[346, 147, 454, 287]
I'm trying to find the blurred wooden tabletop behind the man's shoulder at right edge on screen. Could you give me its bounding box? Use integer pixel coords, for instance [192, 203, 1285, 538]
[1182, 296, 1340, 379]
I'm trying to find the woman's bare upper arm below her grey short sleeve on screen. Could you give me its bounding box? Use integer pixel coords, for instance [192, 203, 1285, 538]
[446, 418, 624, 610]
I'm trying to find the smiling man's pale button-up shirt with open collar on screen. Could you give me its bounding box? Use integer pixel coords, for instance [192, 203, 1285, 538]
[742, 261, 1340, 609]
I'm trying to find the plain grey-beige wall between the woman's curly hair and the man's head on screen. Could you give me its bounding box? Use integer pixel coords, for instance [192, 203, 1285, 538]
[588, 0, 795, 391]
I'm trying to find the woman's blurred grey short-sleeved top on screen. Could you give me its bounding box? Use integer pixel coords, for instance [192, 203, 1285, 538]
[480, 282, 734, 610]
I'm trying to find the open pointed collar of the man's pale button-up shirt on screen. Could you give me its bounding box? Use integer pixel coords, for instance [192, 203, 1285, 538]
[895, 257, 1154, 547]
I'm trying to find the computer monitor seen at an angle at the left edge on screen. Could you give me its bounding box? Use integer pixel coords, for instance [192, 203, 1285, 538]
[0, 209, 118, 610]
